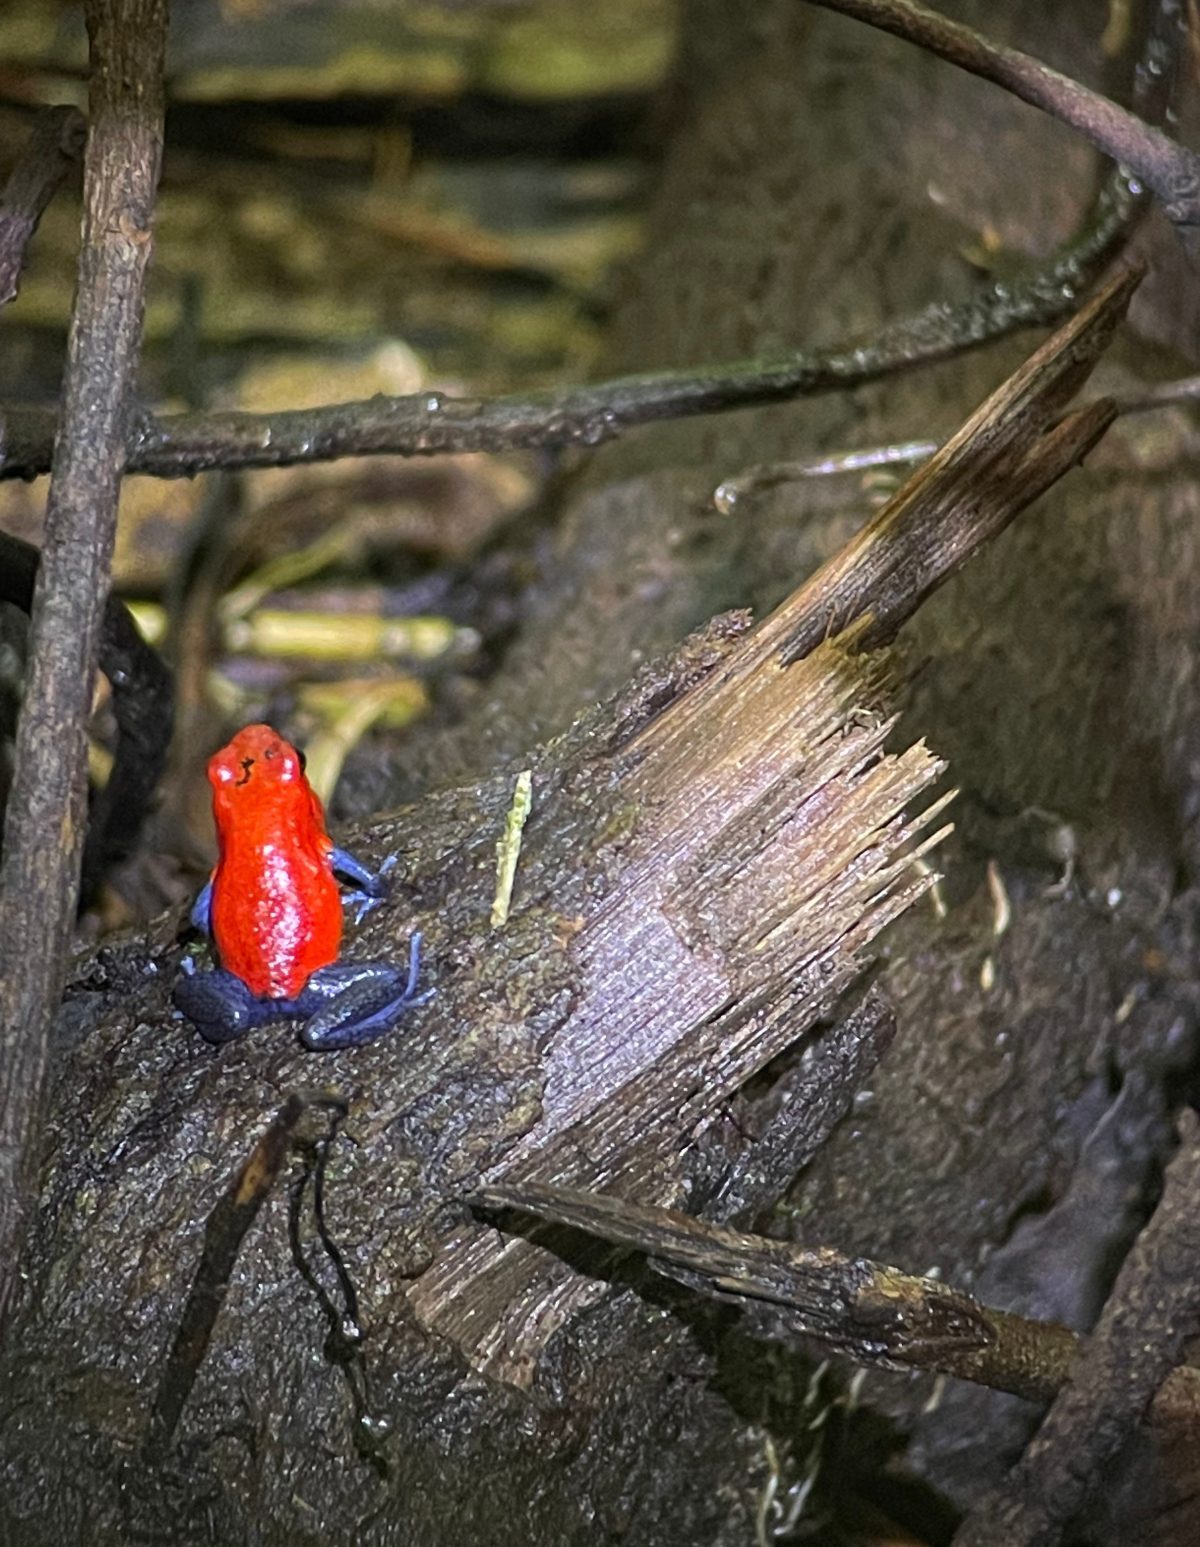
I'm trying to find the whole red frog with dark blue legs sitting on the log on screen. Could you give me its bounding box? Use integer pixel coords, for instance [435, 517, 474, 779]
[175, 726, 428, 1049]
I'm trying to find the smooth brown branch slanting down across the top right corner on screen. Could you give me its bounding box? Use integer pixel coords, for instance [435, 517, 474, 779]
[810, 0, 1200, 226]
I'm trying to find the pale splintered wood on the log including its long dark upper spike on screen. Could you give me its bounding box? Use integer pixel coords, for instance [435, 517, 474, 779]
[408, 274, 1138, 1383]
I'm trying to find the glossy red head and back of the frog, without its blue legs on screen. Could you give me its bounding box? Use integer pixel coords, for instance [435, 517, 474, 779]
[209, 726, 342, 999]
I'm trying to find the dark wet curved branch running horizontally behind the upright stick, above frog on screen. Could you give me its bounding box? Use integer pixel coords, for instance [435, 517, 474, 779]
[0, 165, 1140, 478]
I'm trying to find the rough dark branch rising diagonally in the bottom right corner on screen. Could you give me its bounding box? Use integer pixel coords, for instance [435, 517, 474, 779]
[954, 1112, 1200, 1547]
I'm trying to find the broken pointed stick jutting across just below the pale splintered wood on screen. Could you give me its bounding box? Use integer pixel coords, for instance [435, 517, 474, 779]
[472, 1182, 1200, 1435]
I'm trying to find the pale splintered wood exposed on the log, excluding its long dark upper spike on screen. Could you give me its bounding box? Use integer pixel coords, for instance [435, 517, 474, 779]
[411, 636, 948, 1380]
